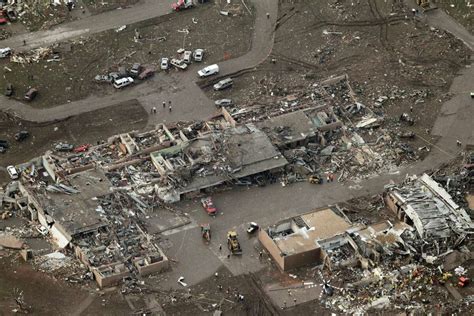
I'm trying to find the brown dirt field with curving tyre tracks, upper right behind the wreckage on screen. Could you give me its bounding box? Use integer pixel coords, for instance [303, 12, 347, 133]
[208, 0, 469, 154]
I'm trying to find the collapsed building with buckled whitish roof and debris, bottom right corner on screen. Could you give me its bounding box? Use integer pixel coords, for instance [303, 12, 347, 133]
[322, 174, 474, 314]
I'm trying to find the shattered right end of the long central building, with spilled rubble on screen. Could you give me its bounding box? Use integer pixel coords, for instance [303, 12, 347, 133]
[230, 76, 418, 181]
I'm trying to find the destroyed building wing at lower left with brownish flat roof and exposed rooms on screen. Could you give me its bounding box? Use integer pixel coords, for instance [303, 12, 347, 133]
[15, 166, 169, 287]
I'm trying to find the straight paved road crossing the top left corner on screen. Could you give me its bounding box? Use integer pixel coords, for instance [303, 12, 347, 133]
[0, 0, 174, 51]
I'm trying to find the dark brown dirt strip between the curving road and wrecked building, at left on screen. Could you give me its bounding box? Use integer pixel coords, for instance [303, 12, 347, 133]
[0, 101, 147, 183]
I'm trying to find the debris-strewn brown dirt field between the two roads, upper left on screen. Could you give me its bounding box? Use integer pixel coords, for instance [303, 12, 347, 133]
[0, 4, 254, 108]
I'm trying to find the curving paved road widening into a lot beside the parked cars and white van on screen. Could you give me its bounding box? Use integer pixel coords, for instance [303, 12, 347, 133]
[0, 0, 278, 126]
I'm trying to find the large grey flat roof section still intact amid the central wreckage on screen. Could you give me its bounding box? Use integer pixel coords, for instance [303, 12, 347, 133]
[150, 124, 287, 202]
